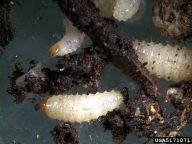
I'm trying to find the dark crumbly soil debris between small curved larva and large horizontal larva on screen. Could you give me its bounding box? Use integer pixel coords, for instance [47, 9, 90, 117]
[7, 48, 106, 103]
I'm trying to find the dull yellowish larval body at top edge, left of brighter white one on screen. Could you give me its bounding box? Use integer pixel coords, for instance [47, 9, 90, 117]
[93, 0, 116, 18]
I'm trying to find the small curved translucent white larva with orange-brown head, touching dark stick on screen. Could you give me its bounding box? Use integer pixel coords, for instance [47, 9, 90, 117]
[49, 18, 85, 57]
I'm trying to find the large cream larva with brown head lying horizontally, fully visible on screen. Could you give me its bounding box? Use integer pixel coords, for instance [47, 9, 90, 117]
[40, 91, 123, 123]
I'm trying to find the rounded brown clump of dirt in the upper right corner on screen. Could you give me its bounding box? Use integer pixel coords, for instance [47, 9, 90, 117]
[152, 0, 192, 41]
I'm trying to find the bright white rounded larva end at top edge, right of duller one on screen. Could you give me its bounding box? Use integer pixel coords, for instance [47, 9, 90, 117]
[113, 0, 141, 21]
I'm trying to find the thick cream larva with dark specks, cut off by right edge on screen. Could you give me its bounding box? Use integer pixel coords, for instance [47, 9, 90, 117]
[134, 40, 192, 82]
